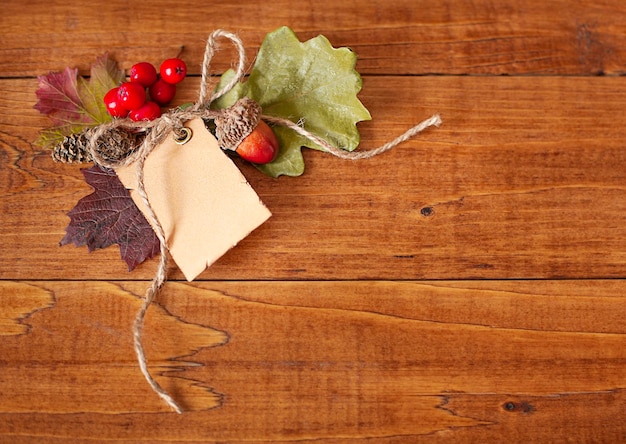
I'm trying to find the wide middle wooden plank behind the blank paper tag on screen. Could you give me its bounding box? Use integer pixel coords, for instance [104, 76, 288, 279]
[0, 77, 626, 279]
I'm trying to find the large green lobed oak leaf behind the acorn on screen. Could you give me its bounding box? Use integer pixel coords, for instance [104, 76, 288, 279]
[212, 27, 371, 177]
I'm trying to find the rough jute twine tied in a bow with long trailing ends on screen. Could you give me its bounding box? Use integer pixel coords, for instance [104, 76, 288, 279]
[87, 30, 441, 413]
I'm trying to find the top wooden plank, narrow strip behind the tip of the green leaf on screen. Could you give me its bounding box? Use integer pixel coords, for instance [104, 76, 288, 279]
[0, 0, 626, 77]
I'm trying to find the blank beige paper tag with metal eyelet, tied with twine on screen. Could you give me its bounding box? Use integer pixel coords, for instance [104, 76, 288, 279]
[116, 118, 271, 281]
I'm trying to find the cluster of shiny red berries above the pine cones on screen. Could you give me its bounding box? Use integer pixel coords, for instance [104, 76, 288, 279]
[104, 58, 187, 122]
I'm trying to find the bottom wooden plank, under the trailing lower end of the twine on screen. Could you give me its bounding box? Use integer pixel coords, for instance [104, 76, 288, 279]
[0, 280, 626, 443]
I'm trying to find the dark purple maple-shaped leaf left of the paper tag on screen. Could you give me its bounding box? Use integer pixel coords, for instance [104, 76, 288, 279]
[61, 165, 160, 271]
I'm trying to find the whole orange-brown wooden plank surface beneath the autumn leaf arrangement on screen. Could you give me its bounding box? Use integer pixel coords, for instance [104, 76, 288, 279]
[0, 0, 626, 444]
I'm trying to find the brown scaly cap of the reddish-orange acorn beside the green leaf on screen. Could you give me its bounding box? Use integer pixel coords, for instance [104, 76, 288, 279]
[215, 97, 261, 151]
